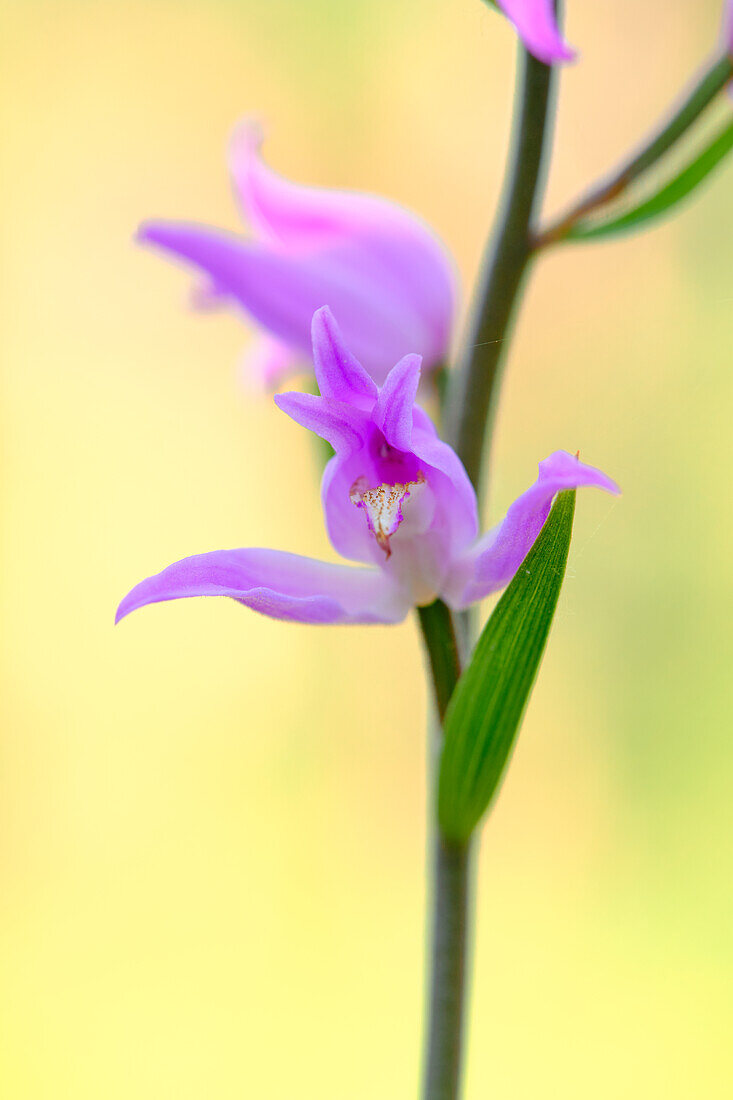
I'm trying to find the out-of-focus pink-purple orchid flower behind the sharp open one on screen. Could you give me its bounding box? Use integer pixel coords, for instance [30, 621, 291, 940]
[138, 121, 457, 387]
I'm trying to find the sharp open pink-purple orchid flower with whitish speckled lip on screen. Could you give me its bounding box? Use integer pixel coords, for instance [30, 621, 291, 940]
[117, 308, 619, 624]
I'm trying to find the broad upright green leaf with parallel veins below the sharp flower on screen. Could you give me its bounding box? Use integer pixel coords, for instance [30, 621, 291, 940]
[438, 490, 576, 843]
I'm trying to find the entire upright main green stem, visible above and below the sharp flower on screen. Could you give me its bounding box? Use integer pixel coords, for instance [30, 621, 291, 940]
[418, 25, 553, 1100]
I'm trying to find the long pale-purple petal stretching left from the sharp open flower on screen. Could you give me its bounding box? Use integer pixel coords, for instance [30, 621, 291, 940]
[116, 550, 408, 624]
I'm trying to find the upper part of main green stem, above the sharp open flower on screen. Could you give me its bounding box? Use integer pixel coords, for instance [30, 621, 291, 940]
[447, 38, 553, 491]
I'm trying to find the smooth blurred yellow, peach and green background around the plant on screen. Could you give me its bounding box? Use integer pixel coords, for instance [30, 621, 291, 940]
[0, 0, 733, 1100]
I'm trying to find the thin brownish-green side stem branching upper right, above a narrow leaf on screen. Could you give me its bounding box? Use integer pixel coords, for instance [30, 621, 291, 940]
[535, 54, 733, 249]
